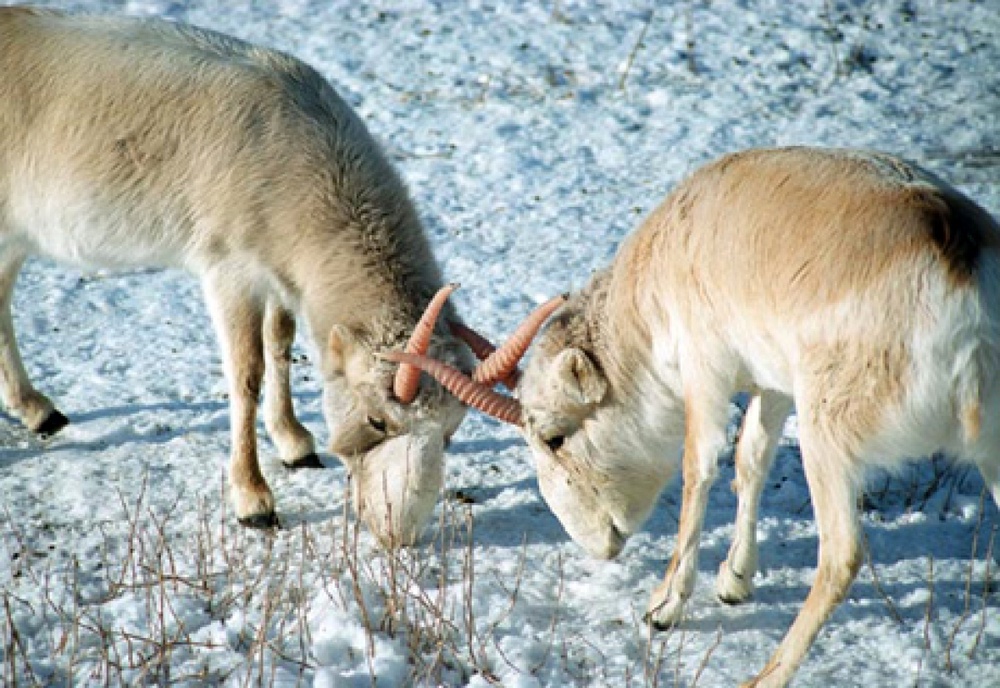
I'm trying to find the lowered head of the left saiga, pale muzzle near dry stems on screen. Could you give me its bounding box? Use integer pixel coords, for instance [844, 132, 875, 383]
[323, 285, 467, 547]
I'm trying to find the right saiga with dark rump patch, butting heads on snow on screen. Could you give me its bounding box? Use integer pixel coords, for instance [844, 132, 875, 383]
[390, 148, 1000, 686]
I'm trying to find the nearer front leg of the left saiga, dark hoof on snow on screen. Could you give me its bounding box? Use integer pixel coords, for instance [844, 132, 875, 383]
[204, 267, 278, 528]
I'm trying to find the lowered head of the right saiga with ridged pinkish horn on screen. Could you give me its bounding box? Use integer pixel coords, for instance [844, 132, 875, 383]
[390, 291, 673, 559]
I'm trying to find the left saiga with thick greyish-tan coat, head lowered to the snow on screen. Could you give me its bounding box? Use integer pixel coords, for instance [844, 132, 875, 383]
[0, 8, 484, 544]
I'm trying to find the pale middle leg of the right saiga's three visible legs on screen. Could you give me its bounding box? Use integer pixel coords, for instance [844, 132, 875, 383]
[715, 391, 792, 604]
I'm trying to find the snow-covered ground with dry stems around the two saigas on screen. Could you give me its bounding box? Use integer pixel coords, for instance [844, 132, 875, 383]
[0, 0, 1000, 687]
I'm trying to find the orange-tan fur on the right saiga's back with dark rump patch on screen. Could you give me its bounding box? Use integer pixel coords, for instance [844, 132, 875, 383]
[606, 148, 1000, 448]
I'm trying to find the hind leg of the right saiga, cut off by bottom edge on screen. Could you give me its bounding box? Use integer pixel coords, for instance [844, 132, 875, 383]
[746, 416, 862, 688]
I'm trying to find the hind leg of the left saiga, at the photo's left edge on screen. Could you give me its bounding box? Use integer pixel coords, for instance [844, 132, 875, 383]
[0, 255, 69, 436]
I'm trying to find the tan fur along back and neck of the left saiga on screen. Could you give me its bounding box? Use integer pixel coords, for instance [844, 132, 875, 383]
[0, 8, 450, 343]
